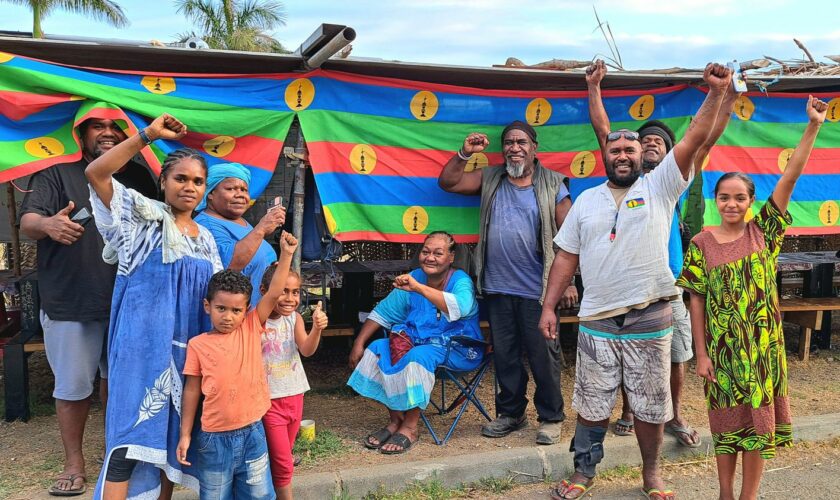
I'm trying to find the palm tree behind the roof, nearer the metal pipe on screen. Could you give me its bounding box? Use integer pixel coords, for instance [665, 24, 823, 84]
[175, 0, 288, 52]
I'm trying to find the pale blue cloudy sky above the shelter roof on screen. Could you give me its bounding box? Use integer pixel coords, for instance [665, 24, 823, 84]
[0, 0, 840, 69]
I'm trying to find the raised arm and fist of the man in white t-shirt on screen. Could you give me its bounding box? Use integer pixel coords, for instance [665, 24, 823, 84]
[674, 63, 732, 179]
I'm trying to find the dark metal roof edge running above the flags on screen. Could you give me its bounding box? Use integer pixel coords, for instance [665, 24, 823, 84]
[0, 32, 840, 92]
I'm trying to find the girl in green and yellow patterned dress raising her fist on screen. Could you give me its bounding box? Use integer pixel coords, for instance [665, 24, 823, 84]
[677, 96, 828, 500]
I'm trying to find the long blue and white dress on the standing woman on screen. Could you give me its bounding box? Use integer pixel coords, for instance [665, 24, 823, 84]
[91, 180, 222, 498]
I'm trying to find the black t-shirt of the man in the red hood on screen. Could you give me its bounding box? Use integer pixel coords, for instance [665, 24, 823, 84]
[20, 159, 157, 322]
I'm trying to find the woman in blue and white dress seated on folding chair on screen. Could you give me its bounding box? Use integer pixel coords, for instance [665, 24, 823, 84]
[347, 231, 484, 455]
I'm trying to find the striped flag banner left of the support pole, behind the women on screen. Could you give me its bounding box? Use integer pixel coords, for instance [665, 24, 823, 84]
[0, 52, 294, 196]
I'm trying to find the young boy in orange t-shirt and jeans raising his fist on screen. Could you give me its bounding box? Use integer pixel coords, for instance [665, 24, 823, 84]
[176, 231, 297, 500]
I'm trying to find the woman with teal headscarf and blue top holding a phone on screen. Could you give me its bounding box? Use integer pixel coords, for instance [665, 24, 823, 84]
[195, 163, 286, 304]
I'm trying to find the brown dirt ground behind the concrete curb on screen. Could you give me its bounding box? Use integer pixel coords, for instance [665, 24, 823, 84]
[0, 333, 840, 498]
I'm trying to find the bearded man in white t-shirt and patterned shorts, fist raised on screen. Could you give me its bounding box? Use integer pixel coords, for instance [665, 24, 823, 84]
[540, 64, 732, 499]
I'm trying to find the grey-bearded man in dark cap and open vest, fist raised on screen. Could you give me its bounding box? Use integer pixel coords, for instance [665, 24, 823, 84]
[438, 121, 577, 445]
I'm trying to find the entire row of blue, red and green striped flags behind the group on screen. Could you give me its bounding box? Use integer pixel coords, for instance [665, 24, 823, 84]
[0, 53, 840, 242]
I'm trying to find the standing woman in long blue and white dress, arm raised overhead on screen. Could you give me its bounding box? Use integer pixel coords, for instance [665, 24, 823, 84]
[85, 115, 222, 500]
